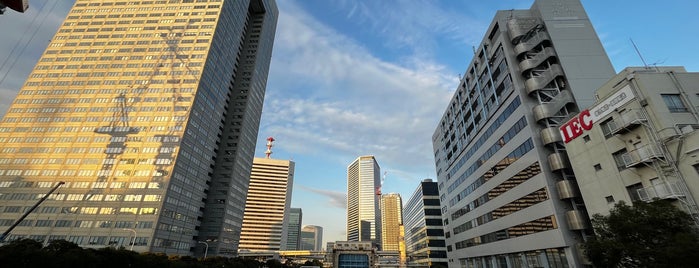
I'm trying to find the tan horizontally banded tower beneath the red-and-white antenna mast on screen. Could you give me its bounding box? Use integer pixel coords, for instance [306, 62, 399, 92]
[239, 157, 294, 251]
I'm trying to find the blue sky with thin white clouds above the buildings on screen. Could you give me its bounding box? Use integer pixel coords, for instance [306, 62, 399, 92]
[0, 0, 699, 246]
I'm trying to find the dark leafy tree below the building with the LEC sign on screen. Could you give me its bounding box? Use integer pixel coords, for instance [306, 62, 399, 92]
[585, 200, 699, 267]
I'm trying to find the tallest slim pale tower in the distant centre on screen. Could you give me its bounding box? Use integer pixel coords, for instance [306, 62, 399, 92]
[347, 155, 381, 243]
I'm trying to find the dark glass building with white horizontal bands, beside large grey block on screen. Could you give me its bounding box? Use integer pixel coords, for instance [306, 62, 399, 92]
[403, 179, 447, 267]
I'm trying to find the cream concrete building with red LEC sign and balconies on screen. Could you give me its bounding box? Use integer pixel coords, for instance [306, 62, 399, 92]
[558, 67, 699, 222]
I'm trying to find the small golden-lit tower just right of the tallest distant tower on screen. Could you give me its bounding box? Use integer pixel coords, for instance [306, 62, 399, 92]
[381, 193, 403, 251]
